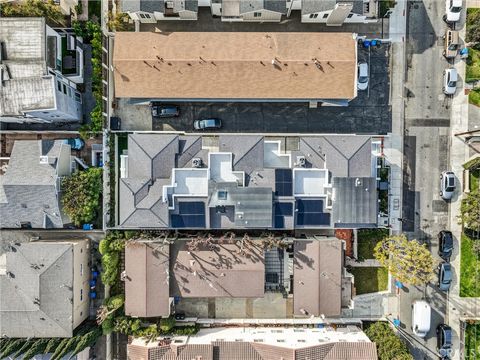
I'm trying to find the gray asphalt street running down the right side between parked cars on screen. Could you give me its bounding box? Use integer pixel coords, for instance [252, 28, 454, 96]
[400, 0, 451, 359]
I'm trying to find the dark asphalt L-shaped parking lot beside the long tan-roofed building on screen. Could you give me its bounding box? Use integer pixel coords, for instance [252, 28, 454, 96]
[146, 45, 391, 134]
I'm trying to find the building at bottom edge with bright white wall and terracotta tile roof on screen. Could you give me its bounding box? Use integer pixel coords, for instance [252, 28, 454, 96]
[127, 325, 377, 360]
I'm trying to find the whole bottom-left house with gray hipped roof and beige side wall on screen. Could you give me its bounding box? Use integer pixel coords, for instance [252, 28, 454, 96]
[0, 240, 90, 338]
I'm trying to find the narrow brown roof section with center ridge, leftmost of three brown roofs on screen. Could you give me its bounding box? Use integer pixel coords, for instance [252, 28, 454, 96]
[125, 242, 170, 317]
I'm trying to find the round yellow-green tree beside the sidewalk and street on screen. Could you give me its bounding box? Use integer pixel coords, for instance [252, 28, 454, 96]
[374, 235, 435, 285]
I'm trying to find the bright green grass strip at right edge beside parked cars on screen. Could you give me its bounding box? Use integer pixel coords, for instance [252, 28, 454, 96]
[460, 234, 480, 297]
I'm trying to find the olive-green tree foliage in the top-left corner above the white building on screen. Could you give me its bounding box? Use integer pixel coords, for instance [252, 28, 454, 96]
[0, 0, 66, 26]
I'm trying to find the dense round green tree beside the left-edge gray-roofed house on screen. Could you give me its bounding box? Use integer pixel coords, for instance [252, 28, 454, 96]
[62, 168, 103, 226]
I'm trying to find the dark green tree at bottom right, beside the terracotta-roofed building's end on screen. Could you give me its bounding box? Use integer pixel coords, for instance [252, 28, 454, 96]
[365, 321, 413, 360]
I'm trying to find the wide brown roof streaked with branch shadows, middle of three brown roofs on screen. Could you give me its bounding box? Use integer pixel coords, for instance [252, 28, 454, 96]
[170, 241, 265, 297]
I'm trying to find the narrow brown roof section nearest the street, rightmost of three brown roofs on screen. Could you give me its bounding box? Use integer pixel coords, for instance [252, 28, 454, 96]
[293, 239, 343, 316]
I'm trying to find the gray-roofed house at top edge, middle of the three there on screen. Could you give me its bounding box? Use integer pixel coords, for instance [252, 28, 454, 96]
[211, 0, 287, 22]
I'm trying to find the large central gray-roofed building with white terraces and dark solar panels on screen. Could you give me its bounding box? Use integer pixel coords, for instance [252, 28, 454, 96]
[116, 134, 381, 230]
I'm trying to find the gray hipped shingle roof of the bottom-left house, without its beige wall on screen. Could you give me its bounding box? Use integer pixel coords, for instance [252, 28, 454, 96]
[0, 242, 73, 337]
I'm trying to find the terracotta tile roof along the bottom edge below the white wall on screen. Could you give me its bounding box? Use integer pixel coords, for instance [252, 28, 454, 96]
[127, 341, 377, 360]
